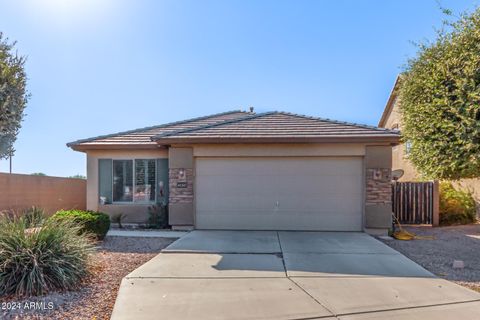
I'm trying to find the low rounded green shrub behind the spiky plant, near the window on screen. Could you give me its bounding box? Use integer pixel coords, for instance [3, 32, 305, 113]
[54, 210, 110, 240]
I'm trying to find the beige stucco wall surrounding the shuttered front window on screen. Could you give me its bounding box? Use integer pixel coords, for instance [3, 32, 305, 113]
[86, 149, 168, 223]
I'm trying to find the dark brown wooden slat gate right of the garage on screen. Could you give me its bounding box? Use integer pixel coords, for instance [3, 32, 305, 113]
[392, 181, 438, 225]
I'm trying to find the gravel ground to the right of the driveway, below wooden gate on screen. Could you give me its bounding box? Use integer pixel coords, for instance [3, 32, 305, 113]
[382, 224, 480, 292]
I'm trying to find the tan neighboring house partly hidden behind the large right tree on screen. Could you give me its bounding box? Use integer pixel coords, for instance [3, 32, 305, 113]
[378, 77, 480, 205]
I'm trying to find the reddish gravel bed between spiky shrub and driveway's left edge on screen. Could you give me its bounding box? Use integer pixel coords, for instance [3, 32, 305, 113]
[0, 236, 175, 320]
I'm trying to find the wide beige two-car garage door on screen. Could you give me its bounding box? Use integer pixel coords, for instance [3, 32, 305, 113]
[195, 157, 363, 231]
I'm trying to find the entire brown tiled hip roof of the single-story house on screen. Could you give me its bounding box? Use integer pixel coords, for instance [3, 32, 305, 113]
[67, 111, 399, 150]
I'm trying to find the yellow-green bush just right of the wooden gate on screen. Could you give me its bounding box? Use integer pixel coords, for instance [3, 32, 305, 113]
[440, 182, 476, 225]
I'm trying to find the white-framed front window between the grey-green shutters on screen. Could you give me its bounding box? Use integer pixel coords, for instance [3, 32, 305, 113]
[112, 159, 156, 202]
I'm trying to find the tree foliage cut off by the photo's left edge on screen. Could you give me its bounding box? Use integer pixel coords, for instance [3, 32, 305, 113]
[0, 32, 29, 159]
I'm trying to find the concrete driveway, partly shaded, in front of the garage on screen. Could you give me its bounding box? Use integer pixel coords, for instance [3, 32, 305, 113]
[112, 231, 480, 320]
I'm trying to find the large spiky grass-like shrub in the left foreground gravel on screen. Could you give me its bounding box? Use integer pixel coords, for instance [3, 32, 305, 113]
[0, 216, 94, 296]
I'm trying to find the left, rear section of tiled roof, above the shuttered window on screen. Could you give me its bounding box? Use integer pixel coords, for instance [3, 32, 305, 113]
[67, 110, 252, 150]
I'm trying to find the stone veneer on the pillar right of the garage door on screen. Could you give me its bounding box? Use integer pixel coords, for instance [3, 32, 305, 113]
[365, 168, 392, 206]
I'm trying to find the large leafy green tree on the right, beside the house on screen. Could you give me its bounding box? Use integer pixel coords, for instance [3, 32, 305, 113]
[399, 8, 480, 180]
